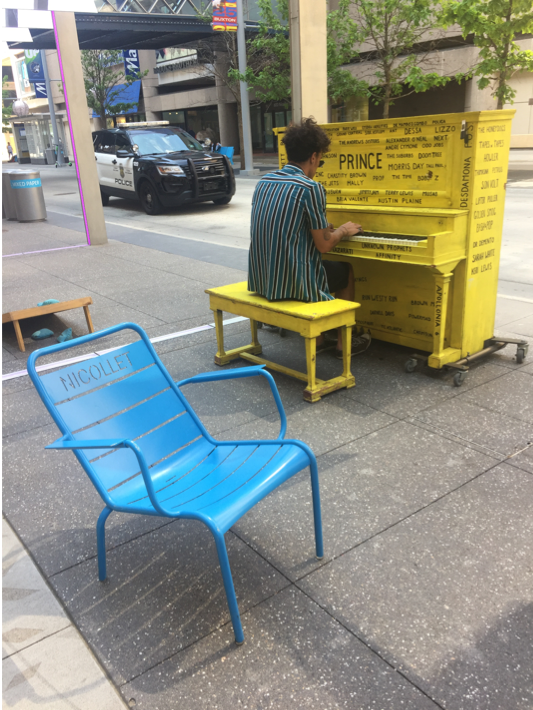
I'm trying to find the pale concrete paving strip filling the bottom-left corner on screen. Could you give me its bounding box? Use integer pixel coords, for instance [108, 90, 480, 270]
[2, 518, 126, 710]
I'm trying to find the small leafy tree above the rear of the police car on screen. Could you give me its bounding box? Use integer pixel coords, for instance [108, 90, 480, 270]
[81, 49, 147, 125]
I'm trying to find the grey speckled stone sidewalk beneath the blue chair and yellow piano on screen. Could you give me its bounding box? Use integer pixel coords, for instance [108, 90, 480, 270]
[2, 221, 533, 710]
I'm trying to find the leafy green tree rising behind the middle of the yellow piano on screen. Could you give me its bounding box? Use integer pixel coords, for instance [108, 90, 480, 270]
[344, 0, 454, 118]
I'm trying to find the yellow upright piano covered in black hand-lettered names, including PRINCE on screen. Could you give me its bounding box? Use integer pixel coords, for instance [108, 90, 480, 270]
[277, 111, 527, 384]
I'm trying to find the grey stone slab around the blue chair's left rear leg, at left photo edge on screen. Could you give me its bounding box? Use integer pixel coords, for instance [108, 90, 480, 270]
[3, 424, 177, 576]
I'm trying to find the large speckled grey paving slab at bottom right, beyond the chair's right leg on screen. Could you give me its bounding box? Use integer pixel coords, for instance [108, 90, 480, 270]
[299, 464, 533, 710]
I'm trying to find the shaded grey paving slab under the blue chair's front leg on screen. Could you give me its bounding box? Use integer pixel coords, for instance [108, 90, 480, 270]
[50, 516, 290, 684]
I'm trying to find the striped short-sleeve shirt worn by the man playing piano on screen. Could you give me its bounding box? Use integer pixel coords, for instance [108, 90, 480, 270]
[248, 165, 333, 302]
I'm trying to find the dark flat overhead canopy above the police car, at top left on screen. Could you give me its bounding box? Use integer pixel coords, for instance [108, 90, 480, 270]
[8, 12, 213, 49]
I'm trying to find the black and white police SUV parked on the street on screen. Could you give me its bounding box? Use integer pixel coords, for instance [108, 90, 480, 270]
[93, 121, 235, 215]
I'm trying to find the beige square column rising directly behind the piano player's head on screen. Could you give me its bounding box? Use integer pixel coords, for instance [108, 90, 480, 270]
[289, 0, 328, 123]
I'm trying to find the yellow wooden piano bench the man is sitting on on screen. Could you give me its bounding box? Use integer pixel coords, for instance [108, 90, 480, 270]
[206, 281, 359, 402]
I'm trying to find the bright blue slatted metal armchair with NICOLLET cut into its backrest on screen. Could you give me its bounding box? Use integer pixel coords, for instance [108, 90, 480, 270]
[28, 323, 323, 644]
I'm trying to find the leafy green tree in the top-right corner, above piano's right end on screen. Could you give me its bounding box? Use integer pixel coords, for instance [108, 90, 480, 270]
[443, 0, 533, 109]
